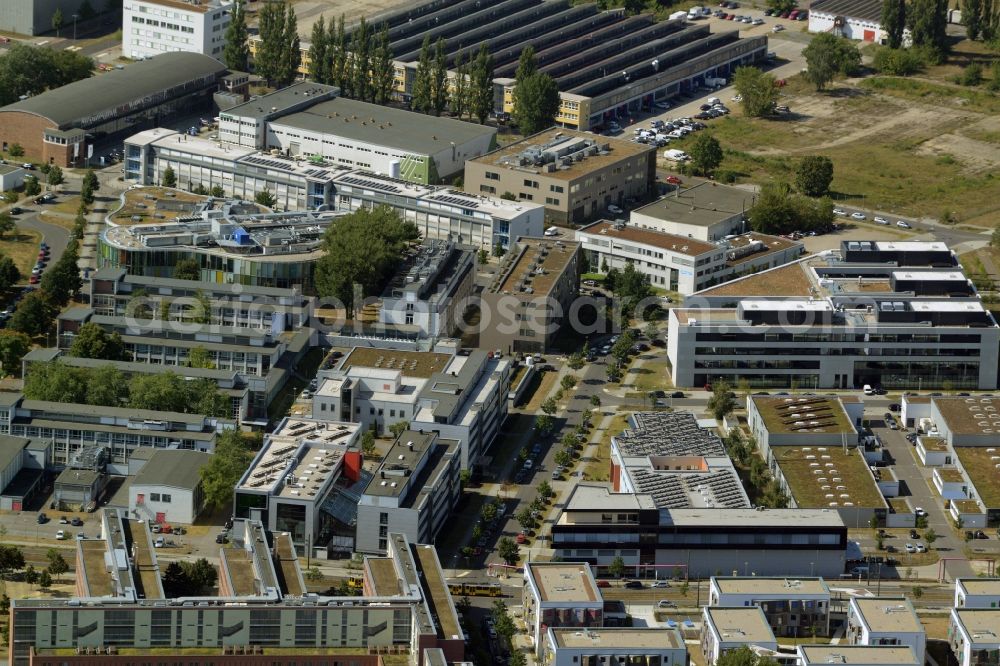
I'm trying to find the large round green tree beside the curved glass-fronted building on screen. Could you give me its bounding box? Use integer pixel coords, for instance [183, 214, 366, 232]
[316, 206, 419, 313]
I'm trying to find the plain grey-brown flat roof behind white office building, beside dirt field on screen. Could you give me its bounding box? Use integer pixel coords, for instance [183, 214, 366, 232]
[634, 183, 755, 227]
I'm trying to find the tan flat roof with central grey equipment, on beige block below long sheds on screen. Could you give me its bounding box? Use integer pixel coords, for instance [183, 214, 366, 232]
[469, 127, 655, 180]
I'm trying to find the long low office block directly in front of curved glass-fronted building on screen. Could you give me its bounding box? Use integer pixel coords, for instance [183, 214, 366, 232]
[89, 267, 313, 335]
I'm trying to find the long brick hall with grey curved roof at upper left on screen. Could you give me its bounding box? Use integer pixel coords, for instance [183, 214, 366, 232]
[0, 53, 226, 167]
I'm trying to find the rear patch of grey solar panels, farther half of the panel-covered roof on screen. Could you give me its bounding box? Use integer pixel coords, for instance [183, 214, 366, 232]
[615, 412, 726, 457]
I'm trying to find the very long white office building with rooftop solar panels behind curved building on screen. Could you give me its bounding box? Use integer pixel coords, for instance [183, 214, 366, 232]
[125, 129, 545, 252]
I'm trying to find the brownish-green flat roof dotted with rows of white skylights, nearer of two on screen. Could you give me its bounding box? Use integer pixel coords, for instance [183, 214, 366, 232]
[771, 446, 885, 509]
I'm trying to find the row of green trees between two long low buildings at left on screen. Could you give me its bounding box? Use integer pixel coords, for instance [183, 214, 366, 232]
[24, 361, 230, 417]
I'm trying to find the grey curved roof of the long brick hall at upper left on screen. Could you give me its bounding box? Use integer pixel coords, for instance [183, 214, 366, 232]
[0, 52, 226, 128]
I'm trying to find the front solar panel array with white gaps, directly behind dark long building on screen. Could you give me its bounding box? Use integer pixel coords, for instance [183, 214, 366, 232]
[630, 469, 750, 509]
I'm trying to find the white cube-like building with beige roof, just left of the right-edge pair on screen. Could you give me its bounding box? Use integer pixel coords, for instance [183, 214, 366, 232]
[845, 597, 927, 664]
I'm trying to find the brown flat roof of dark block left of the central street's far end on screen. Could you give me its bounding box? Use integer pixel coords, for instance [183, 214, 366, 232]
[490, 238, 580, 299]
